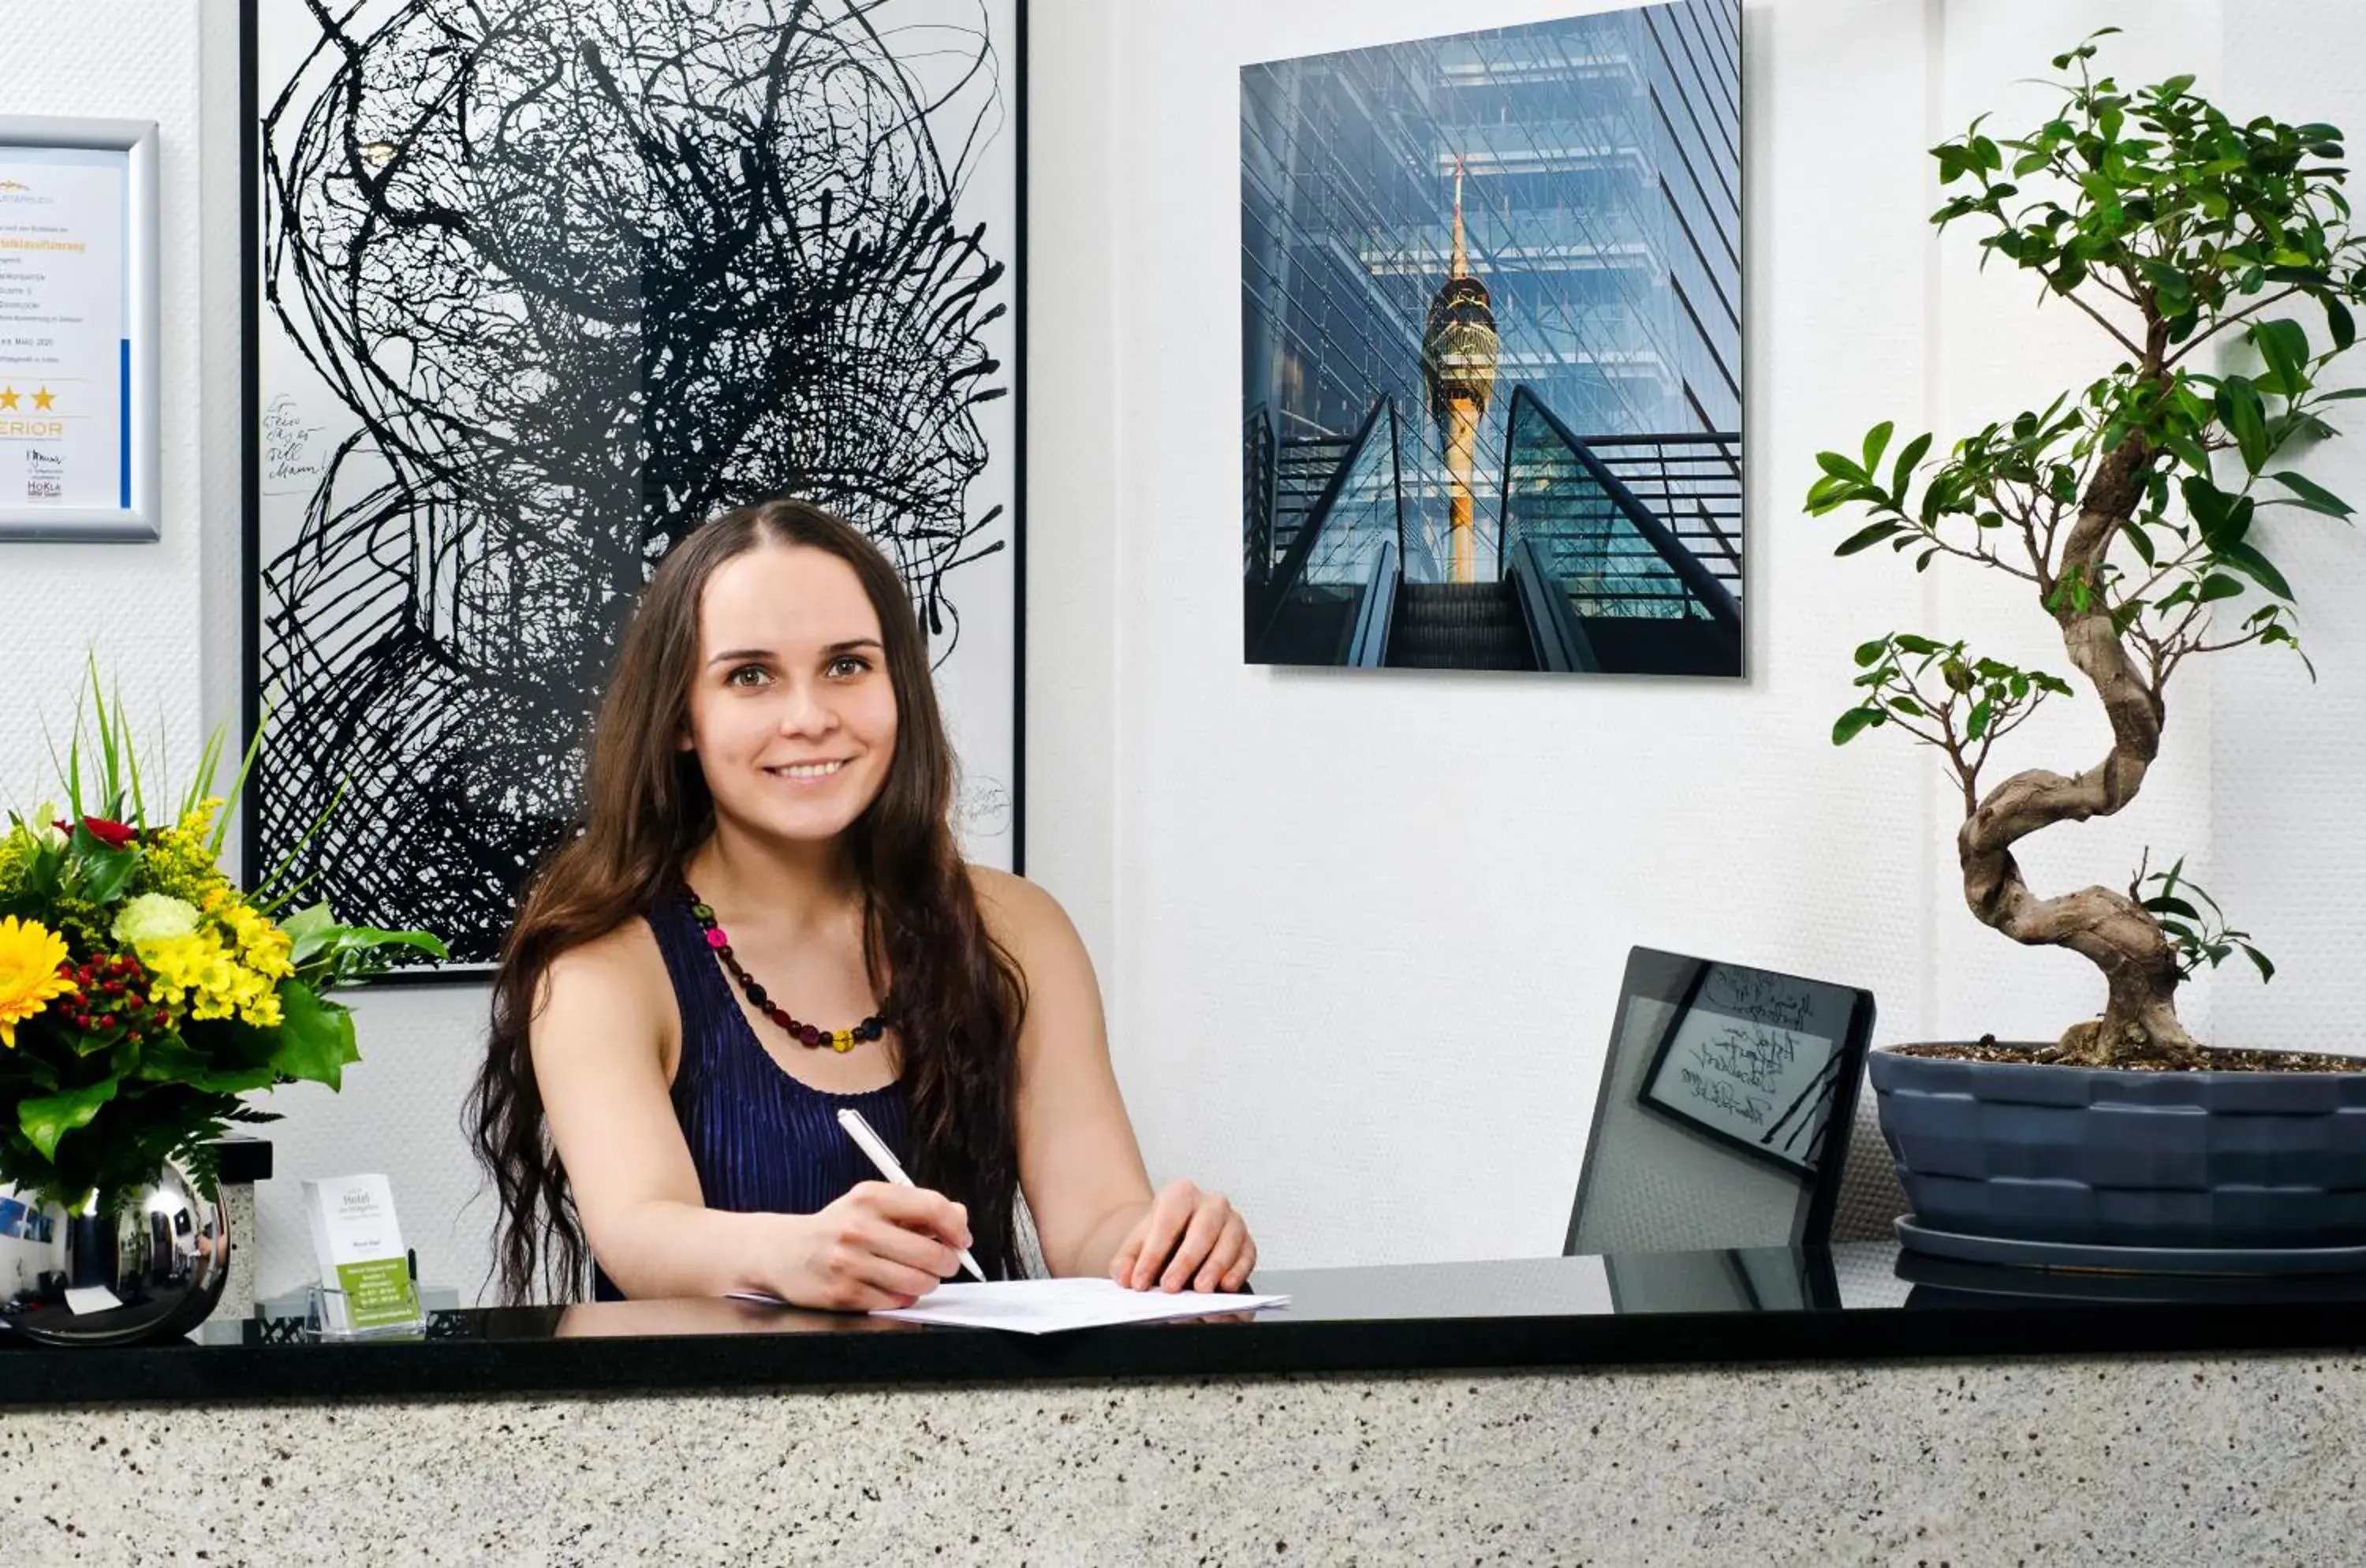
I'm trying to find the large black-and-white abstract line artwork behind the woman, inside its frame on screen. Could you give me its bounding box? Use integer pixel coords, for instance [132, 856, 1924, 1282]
[241, 0, 1024, 976]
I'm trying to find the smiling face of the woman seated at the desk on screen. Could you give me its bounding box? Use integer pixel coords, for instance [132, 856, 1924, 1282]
[681, 544, 897, 842]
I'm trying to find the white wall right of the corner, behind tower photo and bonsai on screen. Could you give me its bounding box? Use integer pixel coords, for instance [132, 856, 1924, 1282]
[1084, 0, 2290, 1263]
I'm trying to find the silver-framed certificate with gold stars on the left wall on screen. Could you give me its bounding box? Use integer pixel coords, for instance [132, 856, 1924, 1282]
[0, 116, 156, 542]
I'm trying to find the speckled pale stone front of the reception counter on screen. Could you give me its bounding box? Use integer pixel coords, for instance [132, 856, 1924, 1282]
[0, 1346, 2366, 1568]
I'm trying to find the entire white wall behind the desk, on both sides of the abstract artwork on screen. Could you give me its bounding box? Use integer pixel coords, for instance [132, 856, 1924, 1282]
[0, 0, 2366, 1291]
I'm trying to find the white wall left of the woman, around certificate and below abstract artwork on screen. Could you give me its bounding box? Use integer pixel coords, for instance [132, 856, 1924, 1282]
[0, 0, 509, 1291]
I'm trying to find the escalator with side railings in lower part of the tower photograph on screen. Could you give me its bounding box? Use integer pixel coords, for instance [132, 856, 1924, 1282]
[1242, 386, 1741, 677]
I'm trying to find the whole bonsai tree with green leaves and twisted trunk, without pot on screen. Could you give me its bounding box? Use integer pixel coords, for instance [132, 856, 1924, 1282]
[1808, 28, 2366, 1066]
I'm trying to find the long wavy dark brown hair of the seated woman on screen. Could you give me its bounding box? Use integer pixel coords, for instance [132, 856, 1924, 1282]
[468, 502, 1027, 1303]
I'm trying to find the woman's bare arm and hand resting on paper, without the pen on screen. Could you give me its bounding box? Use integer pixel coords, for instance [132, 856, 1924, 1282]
[972, 868, 1256, 1291]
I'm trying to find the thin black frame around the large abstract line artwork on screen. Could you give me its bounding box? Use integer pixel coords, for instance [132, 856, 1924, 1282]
[239, 0, 1032, 986]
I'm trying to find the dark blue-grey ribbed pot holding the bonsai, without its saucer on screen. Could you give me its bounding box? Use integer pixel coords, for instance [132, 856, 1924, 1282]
[1867, 1047, 2366, 1249]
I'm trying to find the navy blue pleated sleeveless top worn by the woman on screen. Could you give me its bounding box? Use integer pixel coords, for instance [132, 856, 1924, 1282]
[592, 896, 911, 1301]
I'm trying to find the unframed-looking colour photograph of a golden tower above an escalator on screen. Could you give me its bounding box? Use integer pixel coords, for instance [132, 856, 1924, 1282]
[1240, 0, 1746, 679]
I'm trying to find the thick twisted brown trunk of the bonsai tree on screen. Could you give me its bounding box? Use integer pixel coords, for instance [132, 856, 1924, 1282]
[1954, 430, 2203, 1066]
